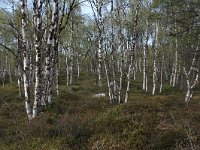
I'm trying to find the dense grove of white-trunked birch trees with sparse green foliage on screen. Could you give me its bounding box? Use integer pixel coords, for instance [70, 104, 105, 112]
[0, 0, 200, 120]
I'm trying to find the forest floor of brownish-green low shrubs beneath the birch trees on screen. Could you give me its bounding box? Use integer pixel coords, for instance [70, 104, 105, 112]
[0, 74, 200, 150]
